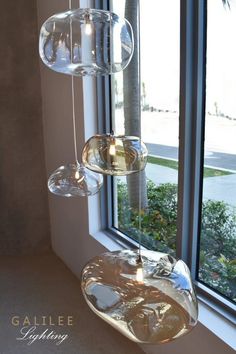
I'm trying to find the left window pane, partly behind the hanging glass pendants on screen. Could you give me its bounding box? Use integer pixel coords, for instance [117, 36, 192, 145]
[112, 0, 180, 254]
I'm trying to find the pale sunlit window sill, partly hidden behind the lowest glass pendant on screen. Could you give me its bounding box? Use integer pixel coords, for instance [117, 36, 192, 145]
[91, 231, 236, 350]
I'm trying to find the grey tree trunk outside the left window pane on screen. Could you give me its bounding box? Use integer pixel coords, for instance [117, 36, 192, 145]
[123, 0, 148, 209]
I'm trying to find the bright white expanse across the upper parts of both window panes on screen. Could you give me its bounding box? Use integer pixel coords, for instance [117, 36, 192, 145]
[113, 0, 236, 118]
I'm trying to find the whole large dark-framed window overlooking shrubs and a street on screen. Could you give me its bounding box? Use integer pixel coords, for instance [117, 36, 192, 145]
[98, 0, 236, 318]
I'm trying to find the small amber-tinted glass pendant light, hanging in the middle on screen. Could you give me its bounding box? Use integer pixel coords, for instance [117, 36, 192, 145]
[82, 134, 148, 176]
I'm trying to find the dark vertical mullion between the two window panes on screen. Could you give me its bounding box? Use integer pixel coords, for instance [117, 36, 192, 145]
[177, 0, 206, 277]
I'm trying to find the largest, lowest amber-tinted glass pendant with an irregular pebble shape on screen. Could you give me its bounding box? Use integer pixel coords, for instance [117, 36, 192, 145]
[81, 250, 198, 344]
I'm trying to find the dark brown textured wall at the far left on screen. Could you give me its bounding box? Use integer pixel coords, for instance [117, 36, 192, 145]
[0, 0, 50, 254]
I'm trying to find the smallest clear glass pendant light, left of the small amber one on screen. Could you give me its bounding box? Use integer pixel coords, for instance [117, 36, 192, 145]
[48, 163, 103, 197]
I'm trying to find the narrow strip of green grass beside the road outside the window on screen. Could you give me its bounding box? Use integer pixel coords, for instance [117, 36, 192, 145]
[148, 156, 232, 177]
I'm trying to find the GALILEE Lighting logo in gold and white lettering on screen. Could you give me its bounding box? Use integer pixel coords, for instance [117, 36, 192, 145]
[11, 315, 73, 345]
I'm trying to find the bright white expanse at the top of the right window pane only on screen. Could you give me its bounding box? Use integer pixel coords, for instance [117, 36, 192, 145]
[207, 0, 236, 118]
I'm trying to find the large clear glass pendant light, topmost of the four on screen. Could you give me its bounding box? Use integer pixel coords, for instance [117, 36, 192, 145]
[39, 9, 134, 76]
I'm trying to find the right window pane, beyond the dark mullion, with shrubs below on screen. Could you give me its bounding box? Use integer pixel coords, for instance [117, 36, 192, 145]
[199, 0, 236, 301]
